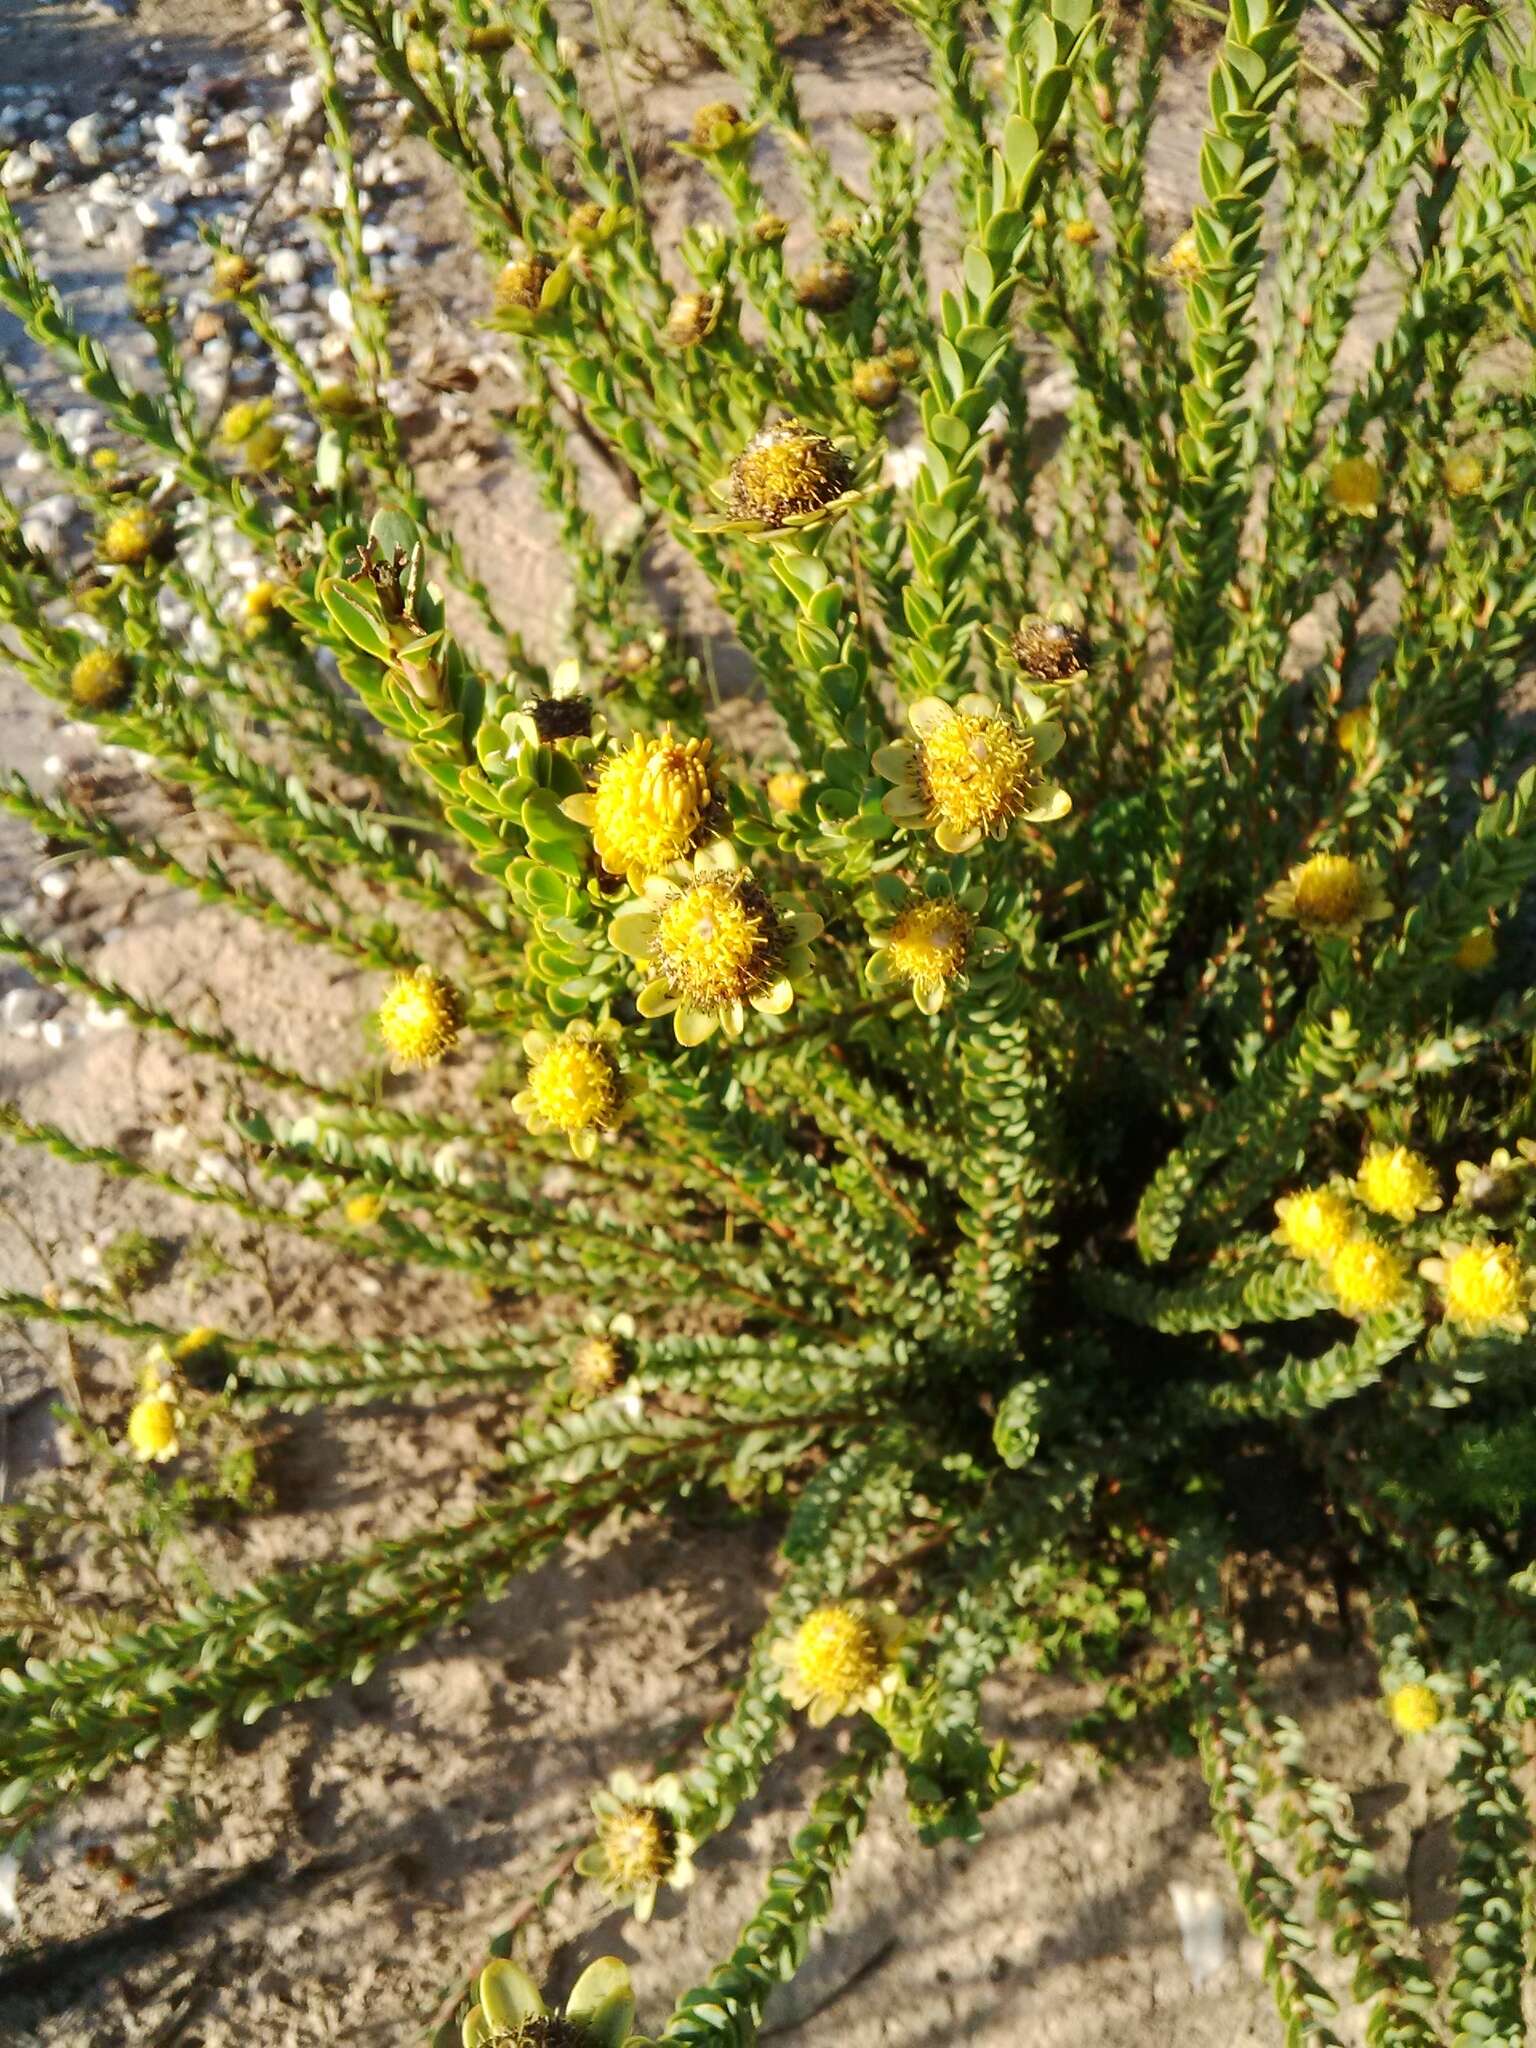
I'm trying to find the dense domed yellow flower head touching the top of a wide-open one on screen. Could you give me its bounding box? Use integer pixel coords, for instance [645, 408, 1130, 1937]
[561, 727, 727, 889]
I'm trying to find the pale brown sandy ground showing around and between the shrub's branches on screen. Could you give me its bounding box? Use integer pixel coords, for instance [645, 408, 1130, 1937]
[0, 0, 1507, 2048]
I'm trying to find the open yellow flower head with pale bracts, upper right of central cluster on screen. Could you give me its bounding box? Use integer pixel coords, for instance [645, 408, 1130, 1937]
[874, 696, 1071, 854]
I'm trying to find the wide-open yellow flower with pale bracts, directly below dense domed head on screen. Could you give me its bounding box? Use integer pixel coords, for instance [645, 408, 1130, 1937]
[608, 868, 821, 1044]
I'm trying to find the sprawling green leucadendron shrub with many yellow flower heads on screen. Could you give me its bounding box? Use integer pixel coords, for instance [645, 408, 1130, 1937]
[0, 0, 1536, 2048]
